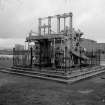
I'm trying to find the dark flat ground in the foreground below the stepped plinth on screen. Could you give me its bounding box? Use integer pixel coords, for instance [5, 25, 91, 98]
[0, 72, 105, 105]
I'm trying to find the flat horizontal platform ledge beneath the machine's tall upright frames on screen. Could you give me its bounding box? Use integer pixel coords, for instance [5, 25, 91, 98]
[26, 34, 66, 41]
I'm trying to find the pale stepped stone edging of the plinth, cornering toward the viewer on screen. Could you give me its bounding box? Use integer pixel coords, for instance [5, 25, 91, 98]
[1, 66, 105, 83]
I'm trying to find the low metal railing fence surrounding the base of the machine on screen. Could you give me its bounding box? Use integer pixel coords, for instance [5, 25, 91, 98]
[13, 48, 100, 70]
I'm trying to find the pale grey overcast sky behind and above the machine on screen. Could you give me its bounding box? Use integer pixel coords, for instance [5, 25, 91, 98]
[0, 0, 105, 48]
